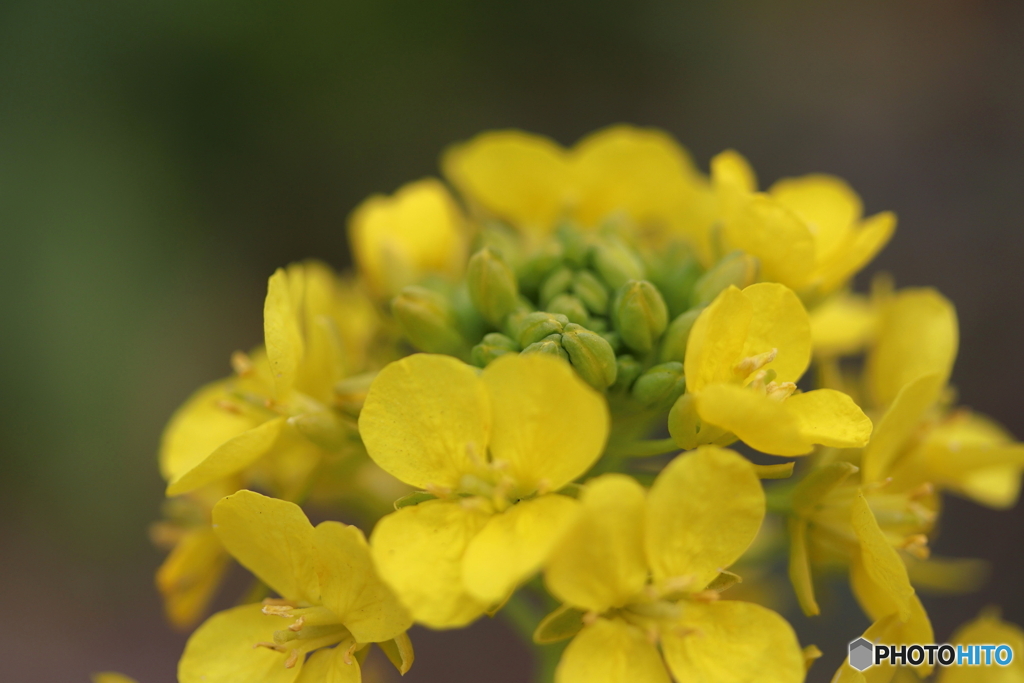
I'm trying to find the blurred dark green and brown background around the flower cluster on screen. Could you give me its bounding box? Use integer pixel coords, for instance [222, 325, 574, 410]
[0, 0, 1024, 683]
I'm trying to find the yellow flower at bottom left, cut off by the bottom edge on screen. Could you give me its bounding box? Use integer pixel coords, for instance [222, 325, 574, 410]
[178, 490, 412, 683]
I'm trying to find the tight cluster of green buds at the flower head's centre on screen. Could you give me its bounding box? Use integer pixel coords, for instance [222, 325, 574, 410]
[391, 224, 758, 410]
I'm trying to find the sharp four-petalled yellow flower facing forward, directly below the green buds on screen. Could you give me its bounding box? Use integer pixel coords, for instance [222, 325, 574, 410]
[359, 354, 608, 628]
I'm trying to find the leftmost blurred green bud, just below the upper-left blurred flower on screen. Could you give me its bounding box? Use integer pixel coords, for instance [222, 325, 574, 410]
[391, 285, 468, 357]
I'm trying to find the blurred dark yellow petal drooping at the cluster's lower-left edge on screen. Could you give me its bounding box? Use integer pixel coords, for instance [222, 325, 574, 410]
[157, 526, 228, 629]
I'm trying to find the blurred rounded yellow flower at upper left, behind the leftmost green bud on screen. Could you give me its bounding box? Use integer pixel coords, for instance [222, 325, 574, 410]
[348, 178, 466, 298]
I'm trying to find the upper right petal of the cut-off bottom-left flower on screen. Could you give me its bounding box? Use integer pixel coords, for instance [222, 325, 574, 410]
[313, 521, 413, 643]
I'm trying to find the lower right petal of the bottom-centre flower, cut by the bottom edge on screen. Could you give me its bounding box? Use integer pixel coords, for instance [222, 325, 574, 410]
[662, 600, 804, 683]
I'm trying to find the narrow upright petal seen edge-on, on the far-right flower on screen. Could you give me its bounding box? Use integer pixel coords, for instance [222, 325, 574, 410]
[861, 373, 946, 483]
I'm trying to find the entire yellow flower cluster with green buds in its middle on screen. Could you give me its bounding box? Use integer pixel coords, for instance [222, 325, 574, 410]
[128, 126, 1024, 683]
